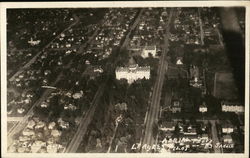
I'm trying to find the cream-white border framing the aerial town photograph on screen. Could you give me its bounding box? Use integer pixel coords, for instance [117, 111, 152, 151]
[0, 1, 250, 158]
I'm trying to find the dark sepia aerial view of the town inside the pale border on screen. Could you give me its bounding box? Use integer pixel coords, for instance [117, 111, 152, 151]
[6, 7, 246, 154]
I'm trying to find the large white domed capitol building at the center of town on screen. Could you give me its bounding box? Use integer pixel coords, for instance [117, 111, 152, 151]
[115, 58, 150, 84]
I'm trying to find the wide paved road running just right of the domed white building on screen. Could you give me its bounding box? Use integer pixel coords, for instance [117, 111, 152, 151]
[142, 9, 173, 152]
